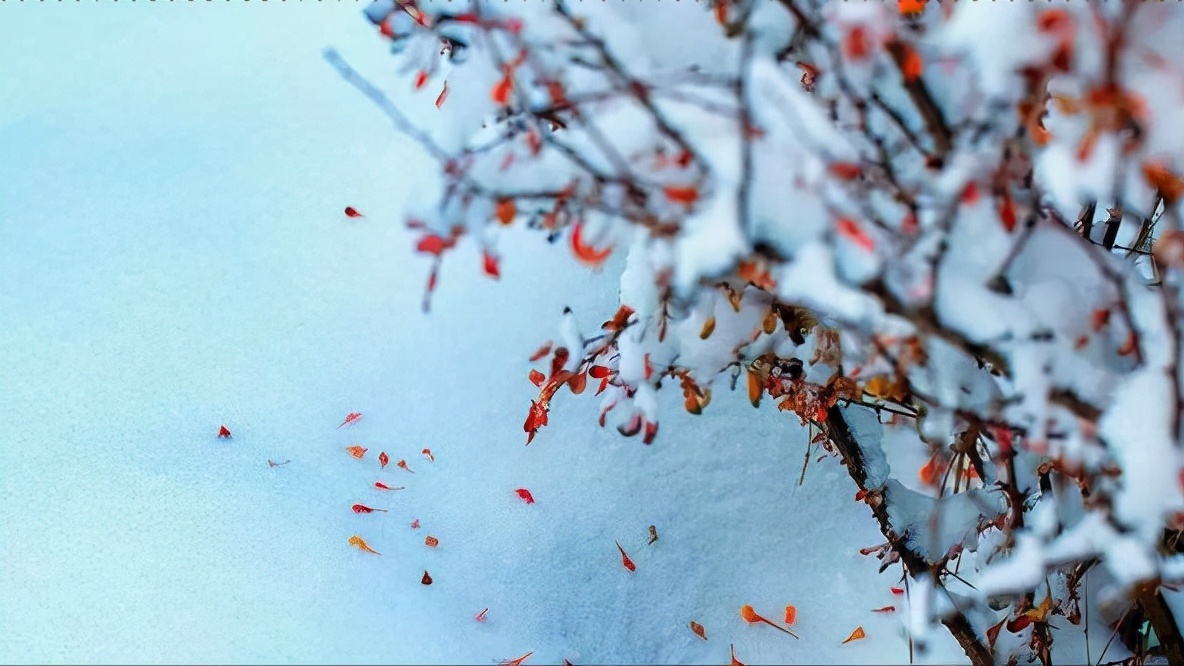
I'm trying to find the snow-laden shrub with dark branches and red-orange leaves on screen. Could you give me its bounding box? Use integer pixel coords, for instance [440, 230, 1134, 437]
[326, 0, 1184, 664]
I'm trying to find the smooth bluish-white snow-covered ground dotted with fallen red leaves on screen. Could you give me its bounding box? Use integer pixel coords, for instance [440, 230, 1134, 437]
[0, 2, 964, 664]
